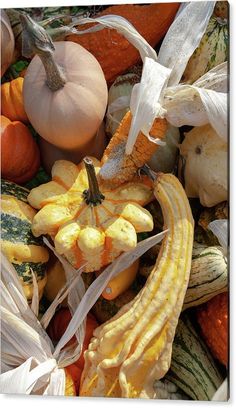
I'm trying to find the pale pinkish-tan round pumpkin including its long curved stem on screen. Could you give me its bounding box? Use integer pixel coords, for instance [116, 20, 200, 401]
[21, 15, 107, 151]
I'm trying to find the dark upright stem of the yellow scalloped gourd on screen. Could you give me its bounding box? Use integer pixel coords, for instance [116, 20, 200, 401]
[83, 157, 105, 206]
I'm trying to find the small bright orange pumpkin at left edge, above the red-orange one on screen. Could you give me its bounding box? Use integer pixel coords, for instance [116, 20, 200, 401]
[1, 77, 28, 123]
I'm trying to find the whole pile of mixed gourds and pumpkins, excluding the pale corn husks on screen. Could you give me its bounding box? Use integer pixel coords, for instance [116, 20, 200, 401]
[1, 2, 229, 400]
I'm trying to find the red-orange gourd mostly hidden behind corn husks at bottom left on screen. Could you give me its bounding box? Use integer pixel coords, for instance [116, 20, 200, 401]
[47, 307, 98, 395]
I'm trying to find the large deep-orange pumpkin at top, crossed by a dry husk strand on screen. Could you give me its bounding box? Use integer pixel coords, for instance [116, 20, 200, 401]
[66, 3, 179, 83]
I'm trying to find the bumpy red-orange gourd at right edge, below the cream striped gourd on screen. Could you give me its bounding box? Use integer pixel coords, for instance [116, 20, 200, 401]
[196, 292, 229, 367]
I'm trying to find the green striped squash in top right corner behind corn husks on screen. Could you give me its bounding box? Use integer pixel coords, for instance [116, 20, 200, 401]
[181, 16, 229, 84]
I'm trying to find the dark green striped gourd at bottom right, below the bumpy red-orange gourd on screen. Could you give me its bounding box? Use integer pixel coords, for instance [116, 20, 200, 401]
[166, 312, 223, 401]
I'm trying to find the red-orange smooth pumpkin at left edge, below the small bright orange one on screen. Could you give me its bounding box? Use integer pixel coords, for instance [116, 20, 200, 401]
[1, 116, 40, 184]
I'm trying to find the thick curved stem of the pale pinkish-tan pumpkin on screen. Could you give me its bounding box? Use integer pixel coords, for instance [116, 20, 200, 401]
[20, 13, 66, 92]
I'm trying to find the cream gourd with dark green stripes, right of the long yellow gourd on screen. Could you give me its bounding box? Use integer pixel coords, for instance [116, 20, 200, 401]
[183, 242, 228, 309]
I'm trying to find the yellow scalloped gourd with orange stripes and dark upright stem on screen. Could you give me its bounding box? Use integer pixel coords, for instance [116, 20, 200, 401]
[28, 157, 153, 272]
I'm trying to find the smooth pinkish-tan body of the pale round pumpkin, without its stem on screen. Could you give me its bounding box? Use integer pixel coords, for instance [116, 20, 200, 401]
[23, 41, 107, 150]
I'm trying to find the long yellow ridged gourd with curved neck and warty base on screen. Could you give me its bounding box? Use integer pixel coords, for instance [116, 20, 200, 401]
[80, 173, 194, 398]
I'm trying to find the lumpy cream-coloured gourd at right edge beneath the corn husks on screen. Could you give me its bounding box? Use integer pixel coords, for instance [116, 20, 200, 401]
[180, 125, 228, 207]
